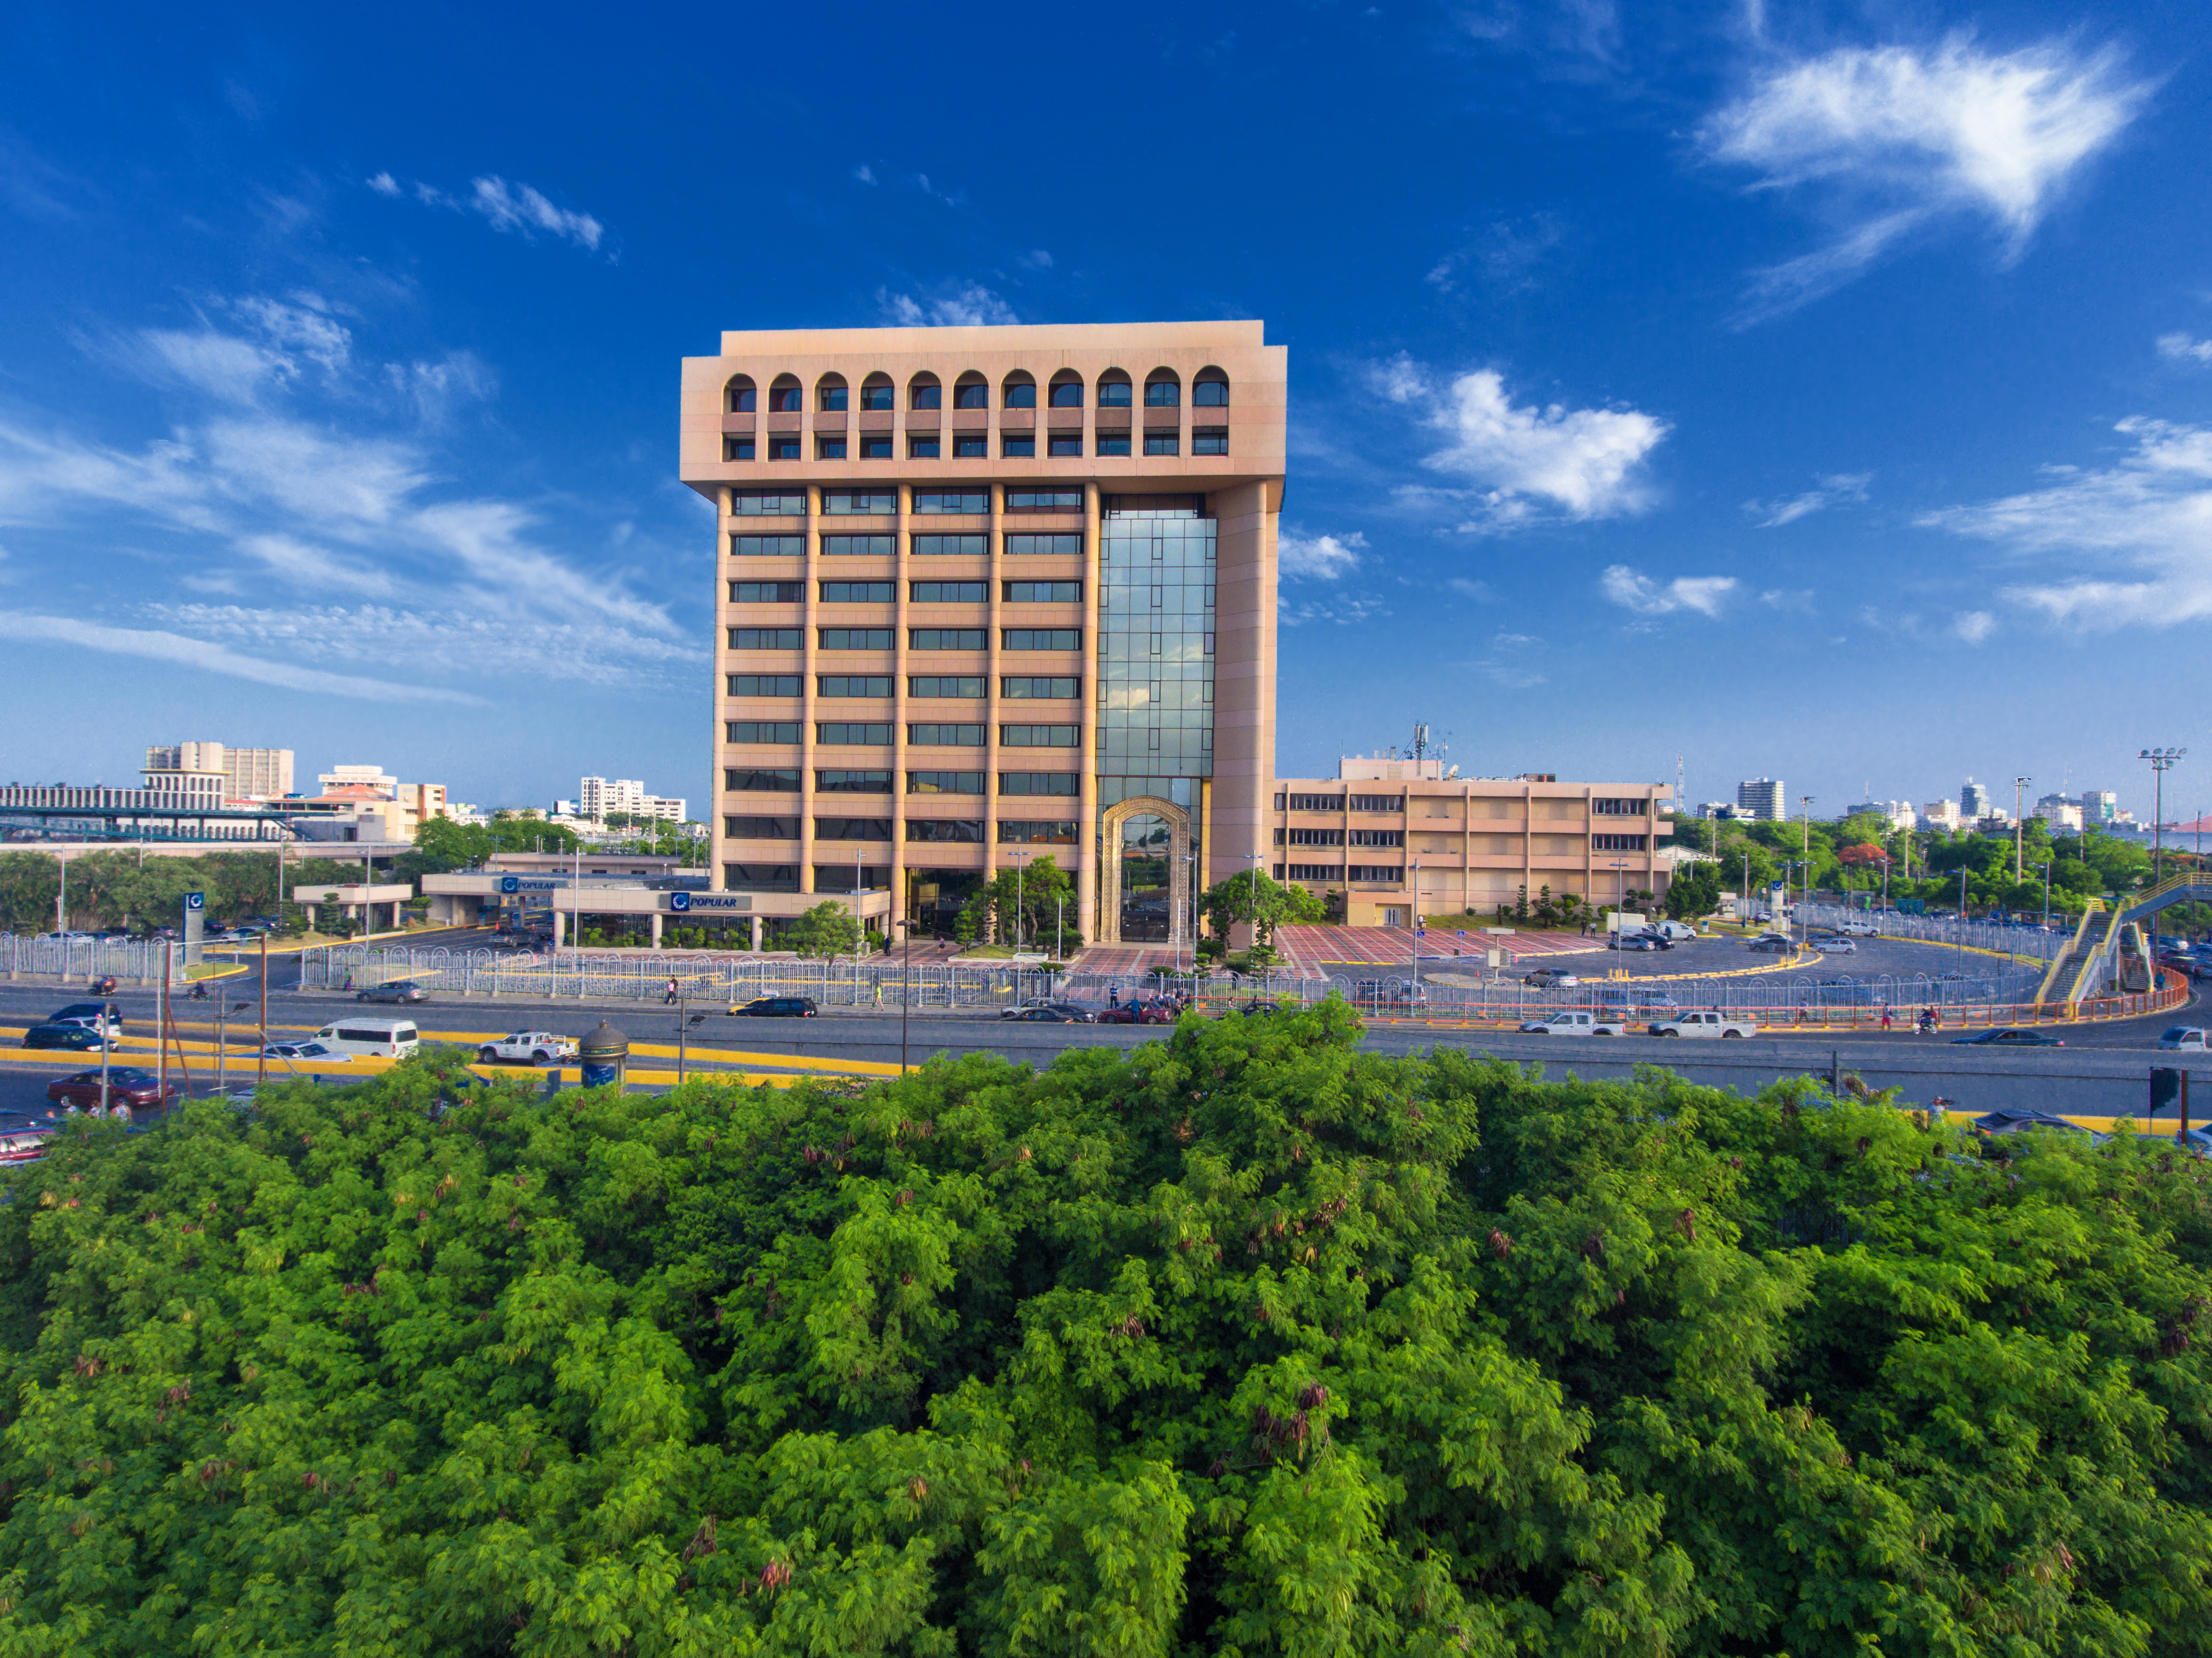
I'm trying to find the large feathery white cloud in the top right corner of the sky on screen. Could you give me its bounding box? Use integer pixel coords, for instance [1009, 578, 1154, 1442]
[1699, 35, 2150, 316]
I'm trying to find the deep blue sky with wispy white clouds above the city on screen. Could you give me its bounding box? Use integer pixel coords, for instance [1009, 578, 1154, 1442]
[0, 0, 2212, 817]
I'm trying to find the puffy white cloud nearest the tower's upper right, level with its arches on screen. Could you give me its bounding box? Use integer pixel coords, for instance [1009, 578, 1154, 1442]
[1376, 356, 1670, 529]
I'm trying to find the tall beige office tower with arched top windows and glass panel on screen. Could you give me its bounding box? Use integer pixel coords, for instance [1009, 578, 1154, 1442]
[681, 323, 1287, 941]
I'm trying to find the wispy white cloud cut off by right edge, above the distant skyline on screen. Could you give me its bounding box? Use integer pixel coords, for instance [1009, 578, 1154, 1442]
[1920, 416, 2212, 631]
